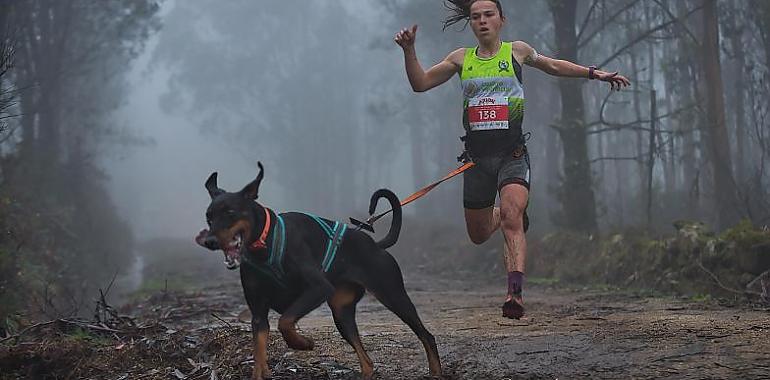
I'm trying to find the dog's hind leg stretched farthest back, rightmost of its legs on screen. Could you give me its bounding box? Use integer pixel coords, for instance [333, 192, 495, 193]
[367, 254, 441, 376]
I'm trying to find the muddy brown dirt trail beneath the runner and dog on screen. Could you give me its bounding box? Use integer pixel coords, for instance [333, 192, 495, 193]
[160, 275, 770, 379]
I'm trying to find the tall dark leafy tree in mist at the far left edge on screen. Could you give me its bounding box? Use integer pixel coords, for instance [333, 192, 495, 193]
[0, 0, 158, 314]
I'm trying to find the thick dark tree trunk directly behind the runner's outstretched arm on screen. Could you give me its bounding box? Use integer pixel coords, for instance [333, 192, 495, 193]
[548, 0, 597, 231]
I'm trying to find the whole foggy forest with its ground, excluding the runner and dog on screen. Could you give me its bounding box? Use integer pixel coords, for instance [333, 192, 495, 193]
[0, 0, 770, 379]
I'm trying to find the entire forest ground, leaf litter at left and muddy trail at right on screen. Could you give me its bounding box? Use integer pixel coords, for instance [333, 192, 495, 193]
[0, 271, 770, 379]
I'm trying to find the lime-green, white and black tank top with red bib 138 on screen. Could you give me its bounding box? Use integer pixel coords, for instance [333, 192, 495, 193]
[460, 42, 524, 156]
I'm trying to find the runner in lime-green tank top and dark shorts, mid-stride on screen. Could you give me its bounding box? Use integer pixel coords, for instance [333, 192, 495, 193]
[394, 0, 630, 319]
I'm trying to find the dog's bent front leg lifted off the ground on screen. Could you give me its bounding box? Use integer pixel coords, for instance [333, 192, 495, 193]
[278, 270, 334, 351]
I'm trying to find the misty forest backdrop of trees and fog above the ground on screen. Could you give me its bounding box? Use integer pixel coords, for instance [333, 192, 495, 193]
[0, 0, 770, 314]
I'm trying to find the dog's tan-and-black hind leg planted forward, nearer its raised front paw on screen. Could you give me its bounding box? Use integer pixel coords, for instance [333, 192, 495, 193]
[329, 283, 374, 380]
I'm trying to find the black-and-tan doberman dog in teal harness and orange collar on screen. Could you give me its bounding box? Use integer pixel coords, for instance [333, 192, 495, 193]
[196, 163, 441, 379]
